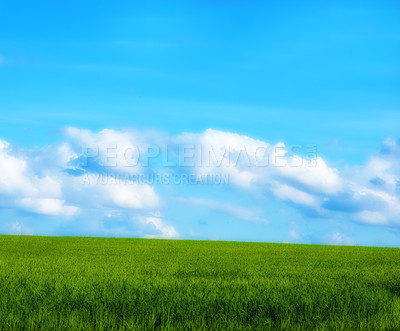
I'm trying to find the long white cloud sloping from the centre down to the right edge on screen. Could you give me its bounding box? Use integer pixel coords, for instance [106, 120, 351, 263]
[179, 129, 400, 225]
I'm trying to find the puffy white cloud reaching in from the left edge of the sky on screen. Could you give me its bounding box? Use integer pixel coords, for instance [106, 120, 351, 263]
[0, 137, 160, 216]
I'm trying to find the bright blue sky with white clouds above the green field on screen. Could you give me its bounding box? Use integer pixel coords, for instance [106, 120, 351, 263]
[0, 0, 400, 247]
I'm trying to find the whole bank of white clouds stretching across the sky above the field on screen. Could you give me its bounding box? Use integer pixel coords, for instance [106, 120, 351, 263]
[0, 128, 400, 241]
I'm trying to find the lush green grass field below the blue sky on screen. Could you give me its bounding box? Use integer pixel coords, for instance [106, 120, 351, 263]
[0, 236, 400, 330]
